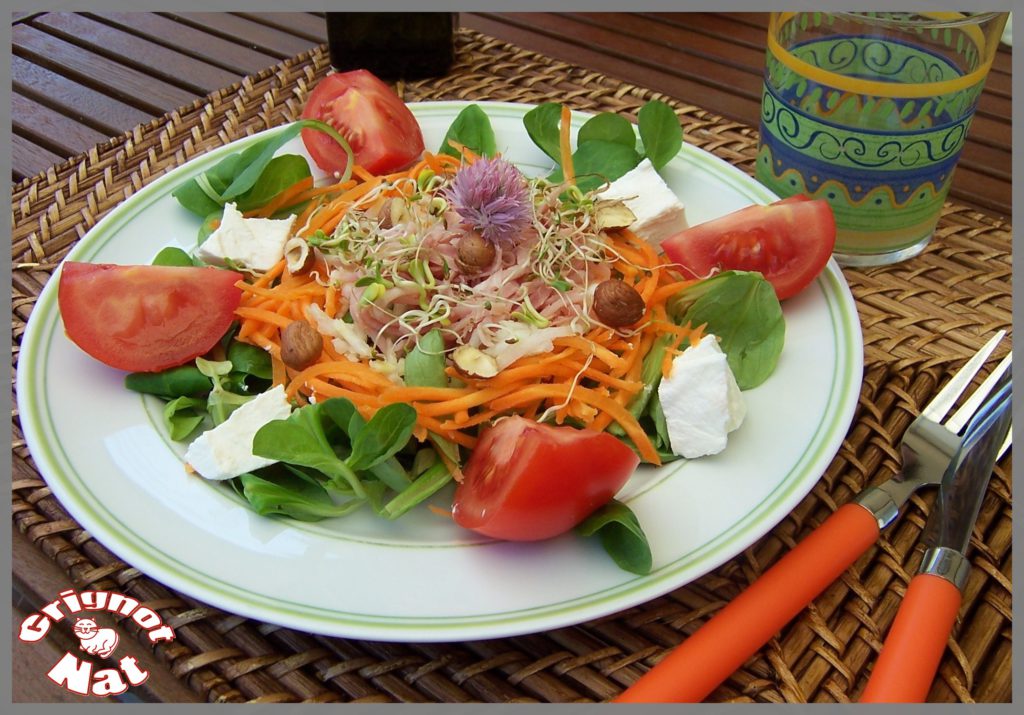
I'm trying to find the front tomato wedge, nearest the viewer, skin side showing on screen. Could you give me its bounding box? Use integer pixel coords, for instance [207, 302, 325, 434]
[452, 416, 640, 541]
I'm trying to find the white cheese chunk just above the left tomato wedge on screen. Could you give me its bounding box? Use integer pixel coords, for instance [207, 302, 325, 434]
[196, 203, 295, 270]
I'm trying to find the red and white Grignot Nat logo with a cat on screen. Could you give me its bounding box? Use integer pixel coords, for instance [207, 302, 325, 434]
[17, 590, 174, 698]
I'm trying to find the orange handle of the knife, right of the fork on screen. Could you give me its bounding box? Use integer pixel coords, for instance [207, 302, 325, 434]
[860, 574, 962, 703]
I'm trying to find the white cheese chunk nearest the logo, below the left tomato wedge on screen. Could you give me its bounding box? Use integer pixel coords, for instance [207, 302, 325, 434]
[185, 385, 292, 479]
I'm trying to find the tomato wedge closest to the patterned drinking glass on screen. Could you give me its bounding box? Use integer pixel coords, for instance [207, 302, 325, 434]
[662, 197, 836, 300]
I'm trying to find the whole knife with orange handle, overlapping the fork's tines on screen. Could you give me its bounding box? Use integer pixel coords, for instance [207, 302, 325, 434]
[860, 370, 1013, 703]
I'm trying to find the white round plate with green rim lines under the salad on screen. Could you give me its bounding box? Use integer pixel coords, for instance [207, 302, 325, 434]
[17, 102, 862, 641]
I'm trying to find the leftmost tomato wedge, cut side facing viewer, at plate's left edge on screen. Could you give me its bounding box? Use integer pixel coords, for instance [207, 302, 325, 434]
[57, 261, 242, 372]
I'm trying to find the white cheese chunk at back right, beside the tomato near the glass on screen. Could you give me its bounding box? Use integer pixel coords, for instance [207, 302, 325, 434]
[598, 159, 687, 245]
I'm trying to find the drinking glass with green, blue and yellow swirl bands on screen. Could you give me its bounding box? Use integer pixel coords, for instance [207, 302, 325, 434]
[756, 12, 1008, 265]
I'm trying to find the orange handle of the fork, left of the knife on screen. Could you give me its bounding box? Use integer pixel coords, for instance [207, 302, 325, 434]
[614, 504, 879, 703]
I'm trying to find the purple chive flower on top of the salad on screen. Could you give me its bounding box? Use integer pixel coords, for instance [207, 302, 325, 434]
[446, 157, 531, 243]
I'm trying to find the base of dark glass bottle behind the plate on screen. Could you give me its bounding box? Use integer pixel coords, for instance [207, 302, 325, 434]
[327, 12, 459, 80]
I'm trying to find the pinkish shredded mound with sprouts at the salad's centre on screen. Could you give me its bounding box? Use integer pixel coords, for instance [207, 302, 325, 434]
[310, 178, 611, 369]
